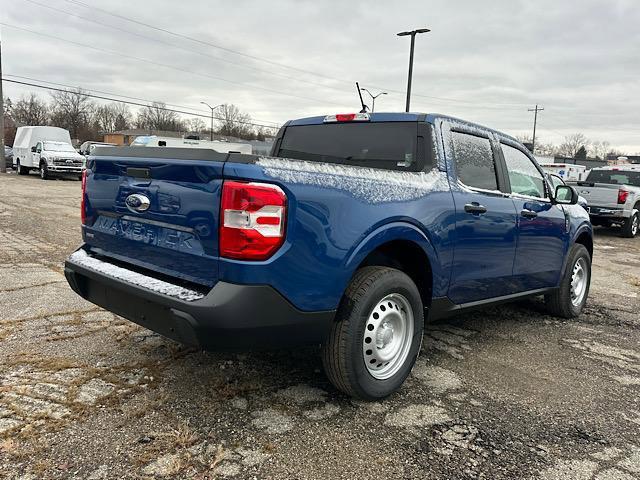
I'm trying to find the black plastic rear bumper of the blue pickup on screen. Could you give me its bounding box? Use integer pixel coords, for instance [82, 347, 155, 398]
[64, 248, 335, 349]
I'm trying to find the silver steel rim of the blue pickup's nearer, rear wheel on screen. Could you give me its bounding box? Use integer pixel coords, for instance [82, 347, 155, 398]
[362, 293, 414, 380]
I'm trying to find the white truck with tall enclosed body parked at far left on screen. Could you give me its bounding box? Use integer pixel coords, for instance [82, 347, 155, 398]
[13, 127, 85, 180]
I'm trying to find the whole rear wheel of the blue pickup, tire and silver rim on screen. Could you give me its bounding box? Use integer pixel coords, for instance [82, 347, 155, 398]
[322, 267, 424, 400]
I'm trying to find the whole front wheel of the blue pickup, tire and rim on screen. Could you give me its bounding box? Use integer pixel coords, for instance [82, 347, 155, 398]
[544, 243, 591, 318]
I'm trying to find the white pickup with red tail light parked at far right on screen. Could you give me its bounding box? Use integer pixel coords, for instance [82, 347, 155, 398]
[575, 165, 640, 238]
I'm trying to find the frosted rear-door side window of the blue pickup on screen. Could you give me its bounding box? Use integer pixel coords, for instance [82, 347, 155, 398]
[451, 132, 498, 190]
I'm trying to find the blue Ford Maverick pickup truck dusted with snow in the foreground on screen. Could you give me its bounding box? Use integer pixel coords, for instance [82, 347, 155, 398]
[65, 113, 593, 400]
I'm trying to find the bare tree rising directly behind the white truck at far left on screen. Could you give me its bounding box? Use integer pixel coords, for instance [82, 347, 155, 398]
[51, 88, 95, 140]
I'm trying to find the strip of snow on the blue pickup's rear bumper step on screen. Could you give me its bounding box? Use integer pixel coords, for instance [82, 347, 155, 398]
[69, 249, 204, 302]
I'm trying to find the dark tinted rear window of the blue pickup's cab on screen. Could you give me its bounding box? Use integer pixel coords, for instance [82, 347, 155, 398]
[278, 122, 433, 172]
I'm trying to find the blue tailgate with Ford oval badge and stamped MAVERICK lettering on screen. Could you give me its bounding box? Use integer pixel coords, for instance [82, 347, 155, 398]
[83, 147, 228, 286]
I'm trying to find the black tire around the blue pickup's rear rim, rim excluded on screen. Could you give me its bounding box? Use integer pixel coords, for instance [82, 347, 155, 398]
[322, 267, 424, 400]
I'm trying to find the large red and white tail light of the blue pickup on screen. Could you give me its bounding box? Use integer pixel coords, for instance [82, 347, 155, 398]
[220, 181, 287, 260]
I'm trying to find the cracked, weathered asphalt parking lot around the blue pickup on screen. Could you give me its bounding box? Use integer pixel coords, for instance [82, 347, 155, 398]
[0, 174, 640, 480]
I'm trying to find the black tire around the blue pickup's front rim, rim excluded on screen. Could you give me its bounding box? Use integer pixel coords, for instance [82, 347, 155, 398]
[544, 243, 591, 318]
